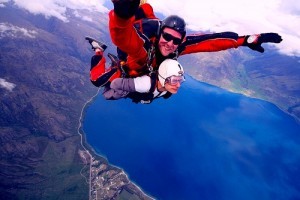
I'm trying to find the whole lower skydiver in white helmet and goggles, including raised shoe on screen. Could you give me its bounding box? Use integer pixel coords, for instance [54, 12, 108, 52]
[87, 37, 185, 103]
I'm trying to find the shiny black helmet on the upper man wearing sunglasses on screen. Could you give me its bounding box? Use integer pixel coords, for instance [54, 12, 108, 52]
[161, 15, 186, 38]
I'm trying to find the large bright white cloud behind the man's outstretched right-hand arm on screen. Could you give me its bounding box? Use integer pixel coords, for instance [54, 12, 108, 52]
[148, 0, 300, 56]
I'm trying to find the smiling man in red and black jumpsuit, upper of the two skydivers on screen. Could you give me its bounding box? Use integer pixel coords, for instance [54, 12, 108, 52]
[85, 0, 282, 103]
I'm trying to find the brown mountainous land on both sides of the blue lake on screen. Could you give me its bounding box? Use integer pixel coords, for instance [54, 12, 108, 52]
[0, 4, 300, 199]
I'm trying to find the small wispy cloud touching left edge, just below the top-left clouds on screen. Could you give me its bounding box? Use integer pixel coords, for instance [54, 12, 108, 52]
[0, 23, 37, 38]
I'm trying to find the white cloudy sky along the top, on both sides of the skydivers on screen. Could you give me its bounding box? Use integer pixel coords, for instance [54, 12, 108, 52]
[0, 0, 300, 57]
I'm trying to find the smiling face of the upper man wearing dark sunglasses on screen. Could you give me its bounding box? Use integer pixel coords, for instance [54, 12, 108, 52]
[158, 27, 181, 56]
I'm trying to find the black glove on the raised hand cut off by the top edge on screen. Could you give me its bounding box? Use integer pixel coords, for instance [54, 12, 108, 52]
[112, 0, 140, 19]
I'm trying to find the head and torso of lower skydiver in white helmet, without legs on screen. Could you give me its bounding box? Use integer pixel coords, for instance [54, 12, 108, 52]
[103, 59, 185, 104]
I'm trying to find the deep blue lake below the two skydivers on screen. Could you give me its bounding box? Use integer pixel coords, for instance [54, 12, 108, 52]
[83, 77, 300, 200]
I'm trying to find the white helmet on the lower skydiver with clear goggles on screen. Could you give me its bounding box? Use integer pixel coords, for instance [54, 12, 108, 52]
[158, 59, 184, 87]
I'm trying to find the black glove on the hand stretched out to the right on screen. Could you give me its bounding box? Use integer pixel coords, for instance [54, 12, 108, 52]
[243, 33, 282, 53]
